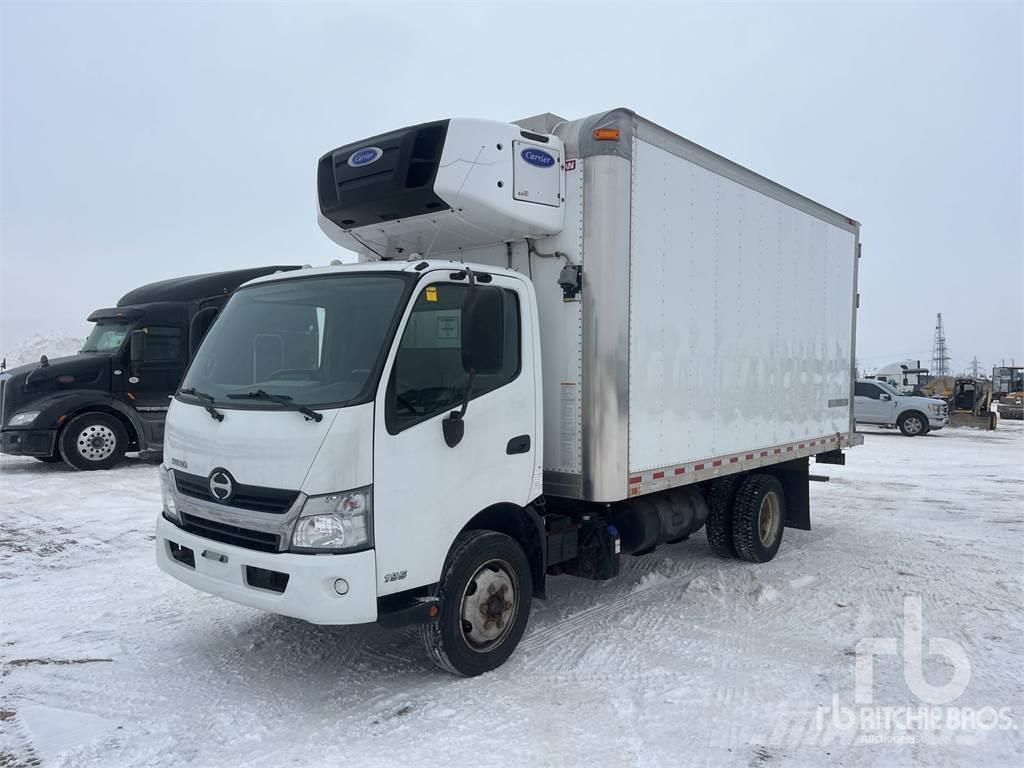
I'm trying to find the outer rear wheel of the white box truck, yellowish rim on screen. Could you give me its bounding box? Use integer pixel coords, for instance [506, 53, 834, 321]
[732, 474, 785, 562]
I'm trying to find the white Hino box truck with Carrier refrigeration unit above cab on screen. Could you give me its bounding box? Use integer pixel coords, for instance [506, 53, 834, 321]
[157, 109, 860, 675]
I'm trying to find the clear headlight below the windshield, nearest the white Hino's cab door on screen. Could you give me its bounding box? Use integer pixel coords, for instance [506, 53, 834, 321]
[291, 486, 374, 552]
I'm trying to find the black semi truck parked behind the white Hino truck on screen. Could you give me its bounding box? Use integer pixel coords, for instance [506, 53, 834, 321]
[0, 265, 299, 470]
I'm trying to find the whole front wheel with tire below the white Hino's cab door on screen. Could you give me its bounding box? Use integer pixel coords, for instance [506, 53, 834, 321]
[420, 530, 534, 677]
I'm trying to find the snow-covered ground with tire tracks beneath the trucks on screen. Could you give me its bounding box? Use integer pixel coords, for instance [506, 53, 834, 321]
[0, 423, 1024, 768]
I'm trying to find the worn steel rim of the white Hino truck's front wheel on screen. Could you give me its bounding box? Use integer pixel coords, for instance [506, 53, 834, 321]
[459, 559, 519, 653]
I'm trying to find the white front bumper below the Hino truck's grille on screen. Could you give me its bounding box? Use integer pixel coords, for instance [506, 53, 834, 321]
[157, 515, 377, 624]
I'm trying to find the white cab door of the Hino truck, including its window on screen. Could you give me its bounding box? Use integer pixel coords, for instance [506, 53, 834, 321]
[373, 269, 541, 595]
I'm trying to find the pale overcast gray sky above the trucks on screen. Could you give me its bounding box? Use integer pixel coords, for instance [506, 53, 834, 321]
[0, 0, 1024, 370]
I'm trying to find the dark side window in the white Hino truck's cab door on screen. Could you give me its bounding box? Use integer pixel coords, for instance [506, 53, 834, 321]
[385, 283, 520, 434]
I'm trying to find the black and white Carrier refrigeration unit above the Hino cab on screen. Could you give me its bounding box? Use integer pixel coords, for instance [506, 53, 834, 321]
[316, 118, 565, 258]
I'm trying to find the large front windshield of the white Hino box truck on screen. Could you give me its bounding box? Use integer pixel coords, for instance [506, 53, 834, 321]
[181, 273, 409, 409]
